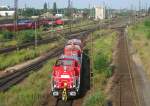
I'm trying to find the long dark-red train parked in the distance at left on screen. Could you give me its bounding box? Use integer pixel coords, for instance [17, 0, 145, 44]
[0, 18, 64, 31]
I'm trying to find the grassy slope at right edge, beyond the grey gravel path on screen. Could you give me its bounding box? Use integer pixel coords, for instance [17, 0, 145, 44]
[128, 18, 150, 76]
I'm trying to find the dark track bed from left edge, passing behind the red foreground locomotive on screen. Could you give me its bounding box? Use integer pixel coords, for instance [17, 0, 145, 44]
[0, 27, 97, 92]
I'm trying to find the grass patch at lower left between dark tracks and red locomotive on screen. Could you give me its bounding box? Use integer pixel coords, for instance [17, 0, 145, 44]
[0, 59, 55, 106]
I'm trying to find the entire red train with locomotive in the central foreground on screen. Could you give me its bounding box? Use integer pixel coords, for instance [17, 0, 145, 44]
[51, 39, 83, 101]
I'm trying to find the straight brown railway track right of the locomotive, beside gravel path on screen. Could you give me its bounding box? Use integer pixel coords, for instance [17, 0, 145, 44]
[112, 28, 142, 106]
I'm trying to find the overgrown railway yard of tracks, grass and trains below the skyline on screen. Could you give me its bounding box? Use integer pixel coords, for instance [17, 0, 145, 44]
[0, 0, 150, 106]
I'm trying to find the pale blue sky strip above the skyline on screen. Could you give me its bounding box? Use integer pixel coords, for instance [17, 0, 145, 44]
[0, 0, 150, 9]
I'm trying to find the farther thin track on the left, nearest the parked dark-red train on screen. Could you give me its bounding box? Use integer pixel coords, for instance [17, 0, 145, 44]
[0, 17, 121, 54]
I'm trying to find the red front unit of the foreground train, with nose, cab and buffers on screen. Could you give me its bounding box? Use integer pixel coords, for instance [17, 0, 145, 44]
[51, 58, 81, 97]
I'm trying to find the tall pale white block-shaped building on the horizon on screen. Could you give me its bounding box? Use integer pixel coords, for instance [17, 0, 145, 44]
[95, 6, 106, 20]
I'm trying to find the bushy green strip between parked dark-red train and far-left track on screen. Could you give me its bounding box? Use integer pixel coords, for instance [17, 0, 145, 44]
[0, 29, 42, 48]
